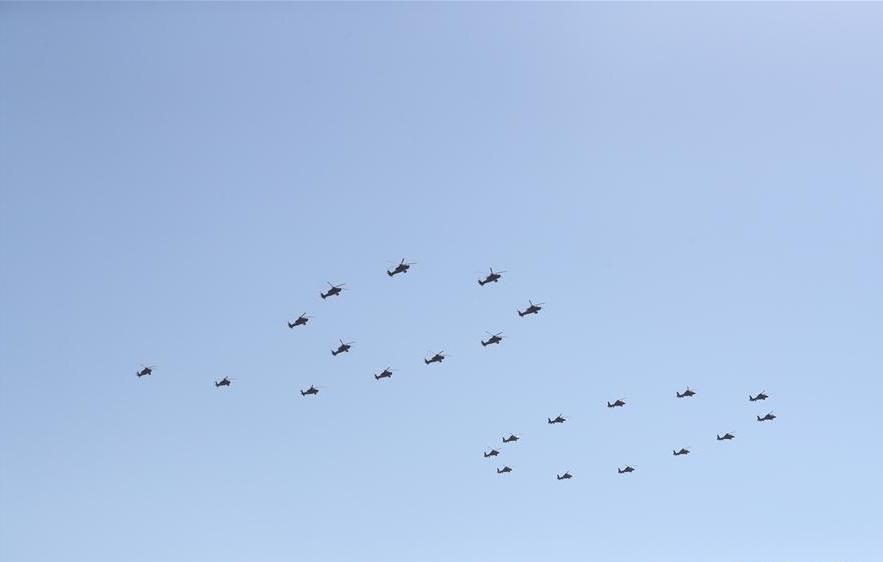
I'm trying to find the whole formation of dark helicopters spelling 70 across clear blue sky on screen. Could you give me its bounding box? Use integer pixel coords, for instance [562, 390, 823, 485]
[135, 258, 776, 481]
